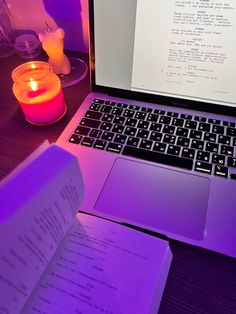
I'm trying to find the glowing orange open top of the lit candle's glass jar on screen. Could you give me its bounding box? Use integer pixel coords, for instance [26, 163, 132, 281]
[11, 61, 53, 83]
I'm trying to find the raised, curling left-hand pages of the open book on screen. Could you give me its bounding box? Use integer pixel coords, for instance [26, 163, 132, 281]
[0, 145, 82, 314]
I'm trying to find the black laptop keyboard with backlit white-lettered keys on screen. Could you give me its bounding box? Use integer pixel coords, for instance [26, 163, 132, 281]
[69, 99, 236, 179]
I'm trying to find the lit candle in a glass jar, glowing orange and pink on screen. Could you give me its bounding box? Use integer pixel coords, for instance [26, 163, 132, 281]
[12, 61, 66, 125]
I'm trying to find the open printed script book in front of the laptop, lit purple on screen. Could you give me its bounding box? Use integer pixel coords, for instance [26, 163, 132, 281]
[0, 144, 172, 314]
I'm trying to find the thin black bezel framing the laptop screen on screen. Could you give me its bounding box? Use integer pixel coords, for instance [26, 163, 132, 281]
[88, 0, 236, 117]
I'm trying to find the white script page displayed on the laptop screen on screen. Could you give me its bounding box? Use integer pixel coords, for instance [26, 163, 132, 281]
[132, 0, 236, 105]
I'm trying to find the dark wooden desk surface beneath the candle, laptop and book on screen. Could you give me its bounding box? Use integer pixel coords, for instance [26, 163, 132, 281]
[0, 53, 236, 314]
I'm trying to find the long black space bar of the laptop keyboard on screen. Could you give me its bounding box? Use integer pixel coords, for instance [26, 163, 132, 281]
[122, 146, 193, 170]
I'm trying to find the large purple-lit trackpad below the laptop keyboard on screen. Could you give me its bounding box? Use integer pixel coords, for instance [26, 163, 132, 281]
[95, 158, 210, 240]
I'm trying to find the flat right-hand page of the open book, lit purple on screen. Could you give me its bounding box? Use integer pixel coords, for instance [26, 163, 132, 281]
[23, 213, 170, 314]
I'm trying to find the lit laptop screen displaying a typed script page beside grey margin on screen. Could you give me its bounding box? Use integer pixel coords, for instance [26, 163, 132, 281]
[92, 0, 236, 112]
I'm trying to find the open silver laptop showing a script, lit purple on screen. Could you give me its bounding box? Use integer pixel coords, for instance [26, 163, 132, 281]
[57, 0, 236, 257]
